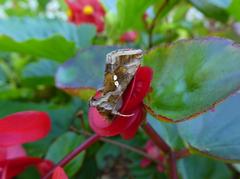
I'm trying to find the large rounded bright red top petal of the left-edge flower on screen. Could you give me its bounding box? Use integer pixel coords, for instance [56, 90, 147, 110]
[0, 111, 51, 147]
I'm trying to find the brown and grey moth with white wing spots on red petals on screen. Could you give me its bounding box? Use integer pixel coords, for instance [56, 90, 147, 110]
[89, 49, 143, 121]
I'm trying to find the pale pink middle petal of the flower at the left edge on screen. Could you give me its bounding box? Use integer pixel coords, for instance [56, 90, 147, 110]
[0, 145, 26, 161]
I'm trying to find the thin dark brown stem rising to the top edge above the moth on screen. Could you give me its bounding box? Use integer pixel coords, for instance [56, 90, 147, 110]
[148, 0, 169, 49]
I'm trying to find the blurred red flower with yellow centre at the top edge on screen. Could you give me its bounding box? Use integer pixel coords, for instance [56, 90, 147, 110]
[66, 0, 105, 32]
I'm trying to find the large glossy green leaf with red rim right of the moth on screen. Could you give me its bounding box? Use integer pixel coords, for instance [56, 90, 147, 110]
[144, 38, 240, 122]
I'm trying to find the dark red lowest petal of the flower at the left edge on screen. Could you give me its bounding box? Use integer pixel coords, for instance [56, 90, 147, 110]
[0, 157, 44, 178]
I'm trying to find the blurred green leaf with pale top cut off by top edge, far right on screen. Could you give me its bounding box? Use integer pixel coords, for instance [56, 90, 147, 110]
[189, 0, 231, 22]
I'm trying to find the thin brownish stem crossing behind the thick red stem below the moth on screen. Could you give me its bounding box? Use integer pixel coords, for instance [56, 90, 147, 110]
[70, 127, 161, 164]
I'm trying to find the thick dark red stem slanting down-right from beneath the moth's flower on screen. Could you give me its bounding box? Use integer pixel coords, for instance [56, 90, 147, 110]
[143, 123, 171, 154]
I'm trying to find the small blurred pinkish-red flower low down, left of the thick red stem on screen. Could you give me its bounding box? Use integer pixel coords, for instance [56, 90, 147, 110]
[140, 140, 164, 172]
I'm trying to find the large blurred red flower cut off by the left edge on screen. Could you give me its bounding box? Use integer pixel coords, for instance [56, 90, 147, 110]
[0, 111, 53, 178]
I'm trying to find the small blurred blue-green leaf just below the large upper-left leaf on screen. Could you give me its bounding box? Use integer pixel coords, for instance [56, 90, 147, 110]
[22, 60, 59, 85]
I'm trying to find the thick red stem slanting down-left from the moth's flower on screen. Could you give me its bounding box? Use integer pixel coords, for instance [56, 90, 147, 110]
[43, 134, 101, 179]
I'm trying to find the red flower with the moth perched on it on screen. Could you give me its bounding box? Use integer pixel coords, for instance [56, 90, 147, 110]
[88, 67, 152, 139]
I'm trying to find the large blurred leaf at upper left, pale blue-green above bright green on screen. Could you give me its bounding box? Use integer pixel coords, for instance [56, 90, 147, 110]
[0, 17, 95, 61]
